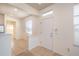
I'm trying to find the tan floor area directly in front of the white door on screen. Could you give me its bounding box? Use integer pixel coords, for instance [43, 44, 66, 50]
[31, 46, 59, 56]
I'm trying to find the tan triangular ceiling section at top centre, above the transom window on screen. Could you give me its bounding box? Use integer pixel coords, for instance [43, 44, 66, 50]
[27, 3, 54, 10]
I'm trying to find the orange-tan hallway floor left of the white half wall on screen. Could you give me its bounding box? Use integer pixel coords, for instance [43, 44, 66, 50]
[12, 39, 27, 55]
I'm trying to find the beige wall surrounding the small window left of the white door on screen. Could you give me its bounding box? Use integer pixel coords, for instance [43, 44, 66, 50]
[22, 15, 40, 50]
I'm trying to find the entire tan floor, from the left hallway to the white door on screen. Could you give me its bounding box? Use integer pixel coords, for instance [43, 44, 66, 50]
[12, 39, 60, 56]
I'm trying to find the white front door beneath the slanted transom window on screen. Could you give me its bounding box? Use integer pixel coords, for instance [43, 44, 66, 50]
[41, 17, 53, 50]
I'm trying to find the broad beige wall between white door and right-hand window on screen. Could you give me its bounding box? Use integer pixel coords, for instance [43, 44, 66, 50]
[41, 4, 79, 55]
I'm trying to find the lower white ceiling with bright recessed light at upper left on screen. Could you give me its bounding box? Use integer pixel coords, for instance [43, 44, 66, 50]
[0, 4, 27, 18]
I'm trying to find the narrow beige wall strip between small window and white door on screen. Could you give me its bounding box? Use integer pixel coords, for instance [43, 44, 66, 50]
[31, 16, 40, 48]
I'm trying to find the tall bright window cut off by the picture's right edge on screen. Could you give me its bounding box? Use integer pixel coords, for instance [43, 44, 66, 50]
[73, 4, 79, 45]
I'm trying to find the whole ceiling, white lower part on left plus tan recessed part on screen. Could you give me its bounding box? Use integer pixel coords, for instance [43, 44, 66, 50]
[0, 3, 52, 19]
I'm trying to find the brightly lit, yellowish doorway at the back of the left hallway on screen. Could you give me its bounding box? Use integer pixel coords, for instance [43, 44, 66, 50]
[6, 21, 16, 48]
